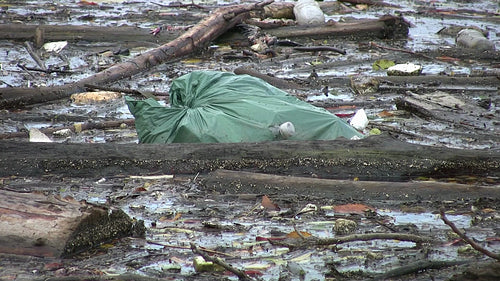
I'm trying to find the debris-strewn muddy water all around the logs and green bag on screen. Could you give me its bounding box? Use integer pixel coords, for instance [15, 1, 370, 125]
[0, 0, 500, 280]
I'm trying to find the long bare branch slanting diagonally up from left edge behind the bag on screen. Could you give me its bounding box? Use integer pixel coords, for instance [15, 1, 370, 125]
[0, 0, 273, 108]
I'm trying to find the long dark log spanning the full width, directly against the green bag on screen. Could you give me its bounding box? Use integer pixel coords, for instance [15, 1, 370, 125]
[0, 136, 500, 181]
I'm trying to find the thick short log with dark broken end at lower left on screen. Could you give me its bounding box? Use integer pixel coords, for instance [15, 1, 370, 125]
[0, 190, 145, 257]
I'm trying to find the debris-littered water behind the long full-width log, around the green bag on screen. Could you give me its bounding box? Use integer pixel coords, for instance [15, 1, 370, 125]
[0, 1, 500, 149]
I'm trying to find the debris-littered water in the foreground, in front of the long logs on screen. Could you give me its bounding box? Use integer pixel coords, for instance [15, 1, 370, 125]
[0, 177, 500, 280]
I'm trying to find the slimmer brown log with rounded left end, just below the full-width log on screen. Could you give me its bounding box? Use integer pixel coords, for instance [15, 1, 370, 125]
[203, 170, 499, 201]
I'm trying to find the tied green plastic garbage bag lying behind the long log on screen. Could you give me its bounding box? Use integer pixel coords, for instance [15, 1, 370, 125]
[125, 71, 362, 143]
